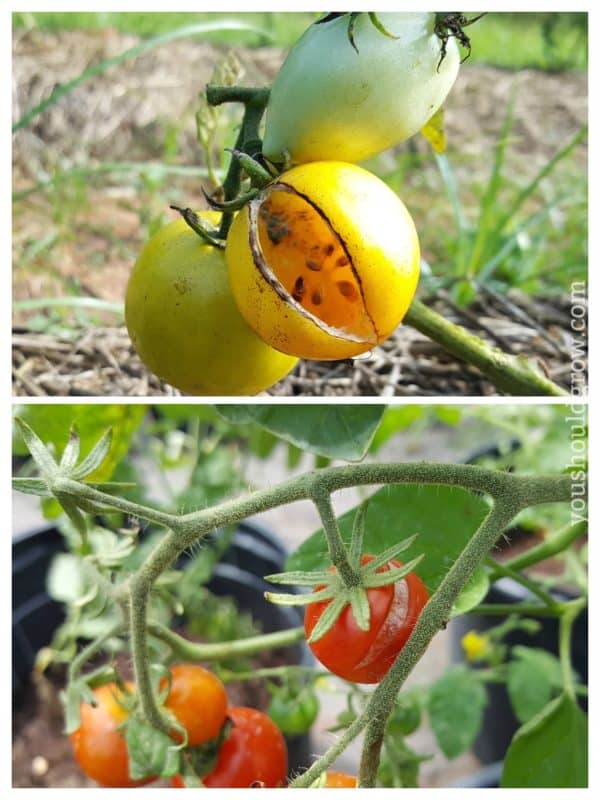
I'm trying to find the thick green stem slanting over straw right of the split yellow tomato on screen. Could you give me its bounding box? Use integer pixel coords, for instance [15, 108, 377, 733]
[404, 300, 567, 397]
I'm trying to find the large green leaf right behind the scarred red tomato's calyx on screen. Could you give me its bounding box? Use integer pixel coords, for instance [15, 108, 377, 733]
[286, 484, 489, 592]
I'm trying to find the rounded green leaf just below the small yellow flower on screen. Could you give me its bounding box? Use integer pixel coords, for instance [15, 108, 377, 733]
[427, 666, 487, 758]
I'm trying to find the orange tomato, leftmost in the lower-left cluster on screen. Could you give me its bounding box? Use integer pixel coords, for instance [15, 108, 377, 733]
[70, 683, 153, 787]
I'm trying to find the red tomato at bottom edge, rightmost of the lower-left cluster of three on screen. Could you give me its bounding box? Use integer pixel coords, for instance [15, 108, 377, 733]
[171, 706, 287, 789]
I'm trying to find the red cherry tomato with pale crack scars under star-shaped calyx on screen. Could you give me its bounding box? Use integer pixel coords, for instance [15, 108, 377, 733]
[304, 555, 429, 683]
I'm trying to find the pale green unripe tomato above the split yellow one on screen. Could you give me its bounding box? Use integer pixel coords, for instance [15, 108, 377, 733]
[263, 12, 460, 164]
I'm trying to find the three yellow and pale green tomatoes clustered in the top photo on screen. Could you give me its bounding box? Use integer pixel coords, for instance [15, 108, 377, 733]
[125, 12, 459, 395]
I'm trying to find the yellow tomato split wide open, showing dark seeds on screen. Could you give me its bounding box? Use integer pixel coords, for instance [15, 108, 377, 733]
[225, 161, 420, 360]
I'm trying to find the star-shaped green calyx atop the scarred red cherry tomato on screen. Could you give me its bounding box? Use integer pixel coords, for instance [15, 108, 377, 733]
[265, 503, 424, 642]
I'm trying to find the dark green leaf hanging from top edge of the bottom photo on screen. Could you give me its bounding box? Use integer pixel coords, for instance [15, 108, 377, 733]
[217, 405, 385, 461]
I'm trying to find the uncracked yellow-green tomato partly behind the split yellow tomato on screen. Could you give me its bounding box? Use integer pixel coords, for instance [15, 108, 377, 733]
[125, 212, 297, 395]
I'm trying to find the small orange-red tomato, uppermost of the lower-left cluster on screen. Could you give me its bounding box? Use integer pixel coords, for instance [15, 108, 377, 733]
[165, 664, 227, 747]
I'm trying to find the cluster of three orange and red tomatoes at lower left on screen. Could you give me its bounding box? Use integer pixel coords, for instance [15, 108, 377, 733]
[71, 664, 288, 788]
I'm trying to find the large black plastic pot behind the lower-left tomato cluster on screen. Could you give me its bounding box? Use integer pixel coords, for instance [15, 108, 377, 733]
[13, 522, 313, 772]
